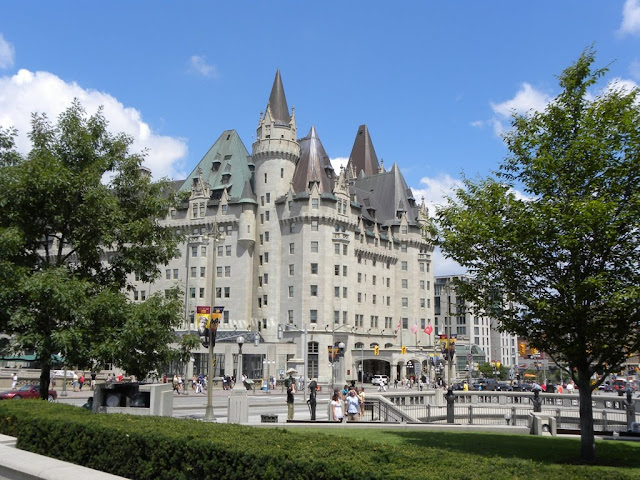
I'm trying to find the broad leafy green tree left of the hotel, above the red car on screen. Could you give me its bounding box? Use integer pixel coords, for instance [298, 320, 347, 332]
[0, 101, 182, 398]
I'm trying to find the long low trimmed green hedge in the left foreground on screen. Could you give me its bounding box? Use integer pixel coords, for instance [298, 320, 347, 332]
[0, 401, 420, 480]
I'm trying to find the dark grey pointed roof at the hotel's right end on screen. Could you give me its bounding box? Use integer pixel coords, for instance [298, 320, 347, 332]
[350, 163, 420, 226]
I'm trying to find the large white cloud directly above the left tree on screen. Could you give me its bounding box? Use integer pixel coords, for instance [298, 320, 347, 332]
[0, 69, 187, 178]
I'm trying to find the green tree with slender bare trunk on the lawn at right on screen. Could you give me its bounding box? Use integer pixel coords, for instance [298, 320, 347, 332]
[437, 50, 640, 462]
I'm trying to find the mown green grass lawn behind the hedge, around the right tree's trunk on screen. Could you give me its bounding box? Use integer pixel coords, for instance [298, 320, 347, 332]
[292, 426, 640, 480]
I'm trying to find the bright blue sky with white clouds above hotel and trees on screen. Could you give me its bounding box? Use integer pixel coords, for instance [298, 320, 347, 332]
[0, 0, 640, 273]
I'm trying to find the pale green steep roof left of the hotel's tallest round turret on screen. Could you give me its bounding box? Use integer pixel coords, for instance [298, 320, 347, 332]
[180, 130, 255, 200]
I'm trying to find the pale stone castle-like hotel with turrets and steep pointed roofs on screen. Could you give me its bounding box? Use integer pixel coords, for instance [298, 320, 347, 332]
[132, 71, 435, 383]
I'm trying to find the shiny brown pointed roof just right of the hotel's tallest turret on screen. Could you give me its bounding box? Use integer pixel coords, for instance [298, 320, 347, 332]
[292, 127, 335, 193]
